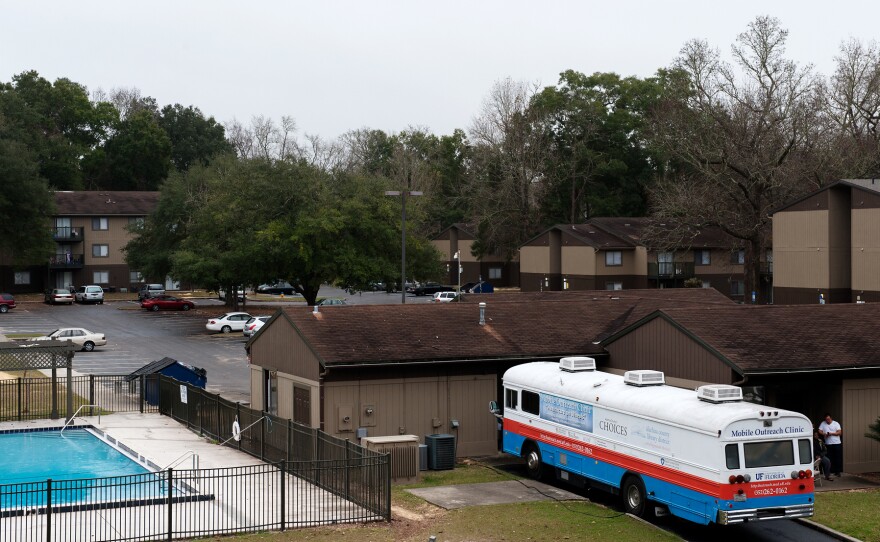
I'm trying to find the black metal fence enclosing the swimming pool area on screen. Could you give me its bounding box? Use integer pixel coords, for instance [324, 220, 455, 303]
[0, 375, 391, 542]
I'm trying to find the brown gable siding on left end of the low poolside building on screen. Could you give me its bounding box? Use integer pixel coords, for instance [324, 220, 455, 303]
[250, 309, 321, 381]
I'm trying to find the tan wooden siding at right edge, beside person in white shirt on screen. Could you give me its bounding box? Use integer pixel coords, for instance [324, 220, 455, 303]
[838, 378, 880, 473]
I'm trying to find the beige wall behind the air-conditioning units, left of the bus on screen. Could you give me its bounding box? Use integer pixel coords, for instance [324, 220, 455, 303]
[324, 374, 498, 456]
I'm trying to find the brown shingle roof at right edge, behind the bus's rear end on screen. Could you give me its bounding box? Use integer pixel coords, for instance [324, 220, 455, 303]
[648, 303, 880, 373]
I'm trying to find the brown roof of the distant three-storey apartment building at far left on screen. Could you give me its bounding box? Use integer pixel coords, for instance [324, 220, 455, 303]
[55, 190, 159, 216]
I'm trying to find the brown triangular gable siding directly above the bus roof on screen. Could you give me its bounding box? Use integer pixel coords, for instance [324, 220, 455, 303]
[605, 318, 734, 384]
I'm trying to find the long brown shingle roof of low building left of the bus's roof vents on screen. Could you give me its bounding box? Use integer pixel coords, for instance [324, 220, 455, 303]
[284, 289, 730, 366]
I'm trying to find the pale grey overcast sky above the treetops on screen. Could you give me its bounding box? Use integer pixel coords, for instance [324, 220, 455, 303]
[0, 0, 880, 138]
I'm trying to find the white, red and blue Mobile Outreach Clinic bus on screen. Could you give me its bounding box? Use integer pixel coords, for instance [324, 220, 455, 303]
[490, 357, 813, 525]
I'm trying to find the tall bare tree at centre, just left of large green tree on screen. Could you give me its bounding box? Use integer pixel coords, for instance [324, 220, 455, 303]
[469, 78, 549, 258]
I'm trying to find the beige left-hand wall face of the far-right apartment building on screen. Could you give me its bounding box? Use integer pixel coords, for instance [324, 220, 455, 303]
[773, 210, 831, 288]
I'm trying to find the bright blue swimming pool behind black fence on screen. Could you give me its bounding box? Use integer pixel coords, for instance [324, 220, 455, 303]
[0, 427, 167, 510]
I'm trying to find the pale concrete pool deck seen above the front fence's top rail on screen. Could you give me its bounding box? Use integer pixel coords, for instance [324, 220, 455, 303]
[0, 413, 262, 470]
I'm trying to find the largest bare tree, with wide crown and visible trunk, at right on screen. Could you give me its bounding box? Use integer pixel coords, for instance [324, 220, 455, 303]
[651, 17, 827, 300]
